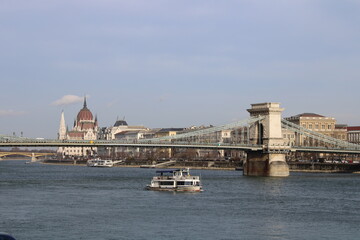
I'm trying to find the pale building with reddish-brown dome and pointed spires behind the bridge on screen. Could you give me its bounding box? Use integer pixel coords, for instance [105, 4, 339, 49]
[58, 98, 99, 157]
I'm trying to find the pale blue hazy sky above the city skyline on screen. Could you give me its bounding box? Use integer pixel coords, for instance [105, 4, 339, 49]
[0, 0, 360, 138]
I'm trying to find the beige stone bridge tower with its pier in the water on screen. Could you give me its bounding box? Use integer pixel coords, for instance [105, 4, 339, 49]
[244, 103, 289, 177]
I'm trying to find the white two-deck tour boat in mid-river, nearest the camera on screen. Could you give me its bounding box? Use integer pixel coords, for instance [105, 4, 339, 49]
[146, 168, 202, 192]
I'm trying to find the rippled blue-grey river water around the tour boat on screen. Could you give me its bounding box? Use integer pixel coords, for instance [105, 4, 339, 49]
[0, 161, 360, 240]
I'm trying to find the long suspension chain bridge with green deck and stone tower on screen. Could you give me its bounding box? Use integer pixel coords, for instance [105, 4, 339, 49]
[0, 103, 360, 176]
